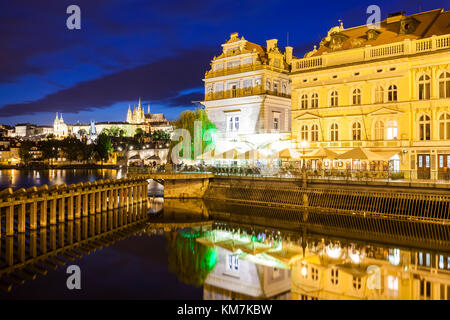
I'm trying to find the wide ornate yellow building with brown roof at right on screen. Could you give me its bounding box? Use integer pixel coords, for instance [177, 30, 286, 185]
[290, 9, 450, 179]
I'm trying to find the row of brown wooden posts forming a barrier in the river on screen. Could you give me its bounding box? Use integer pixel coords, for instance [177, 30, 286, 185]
[0, 177, 148, 236]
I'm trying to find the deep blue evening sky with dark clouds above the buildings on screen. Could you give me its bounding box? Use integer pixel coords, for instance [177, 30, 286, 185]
[0, 0, 448, 124]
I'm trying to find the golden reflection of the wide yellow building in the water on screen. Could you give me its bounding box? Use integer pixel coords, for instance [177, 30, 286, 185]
[292, 242, 450, 300]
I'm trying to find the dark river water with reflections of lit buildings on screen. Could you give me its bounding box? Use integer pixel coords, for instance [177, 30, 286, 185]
[0, 170, 450, 300]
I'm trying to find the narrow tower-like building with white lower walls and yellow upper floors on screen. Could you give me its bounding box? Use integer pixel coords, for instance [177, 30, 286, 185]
[202, 33, 293, 153]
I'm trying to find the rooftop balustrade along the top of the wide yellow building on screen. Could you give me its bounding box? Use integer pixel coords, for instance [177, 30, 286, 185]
[292, 34, 450, 72]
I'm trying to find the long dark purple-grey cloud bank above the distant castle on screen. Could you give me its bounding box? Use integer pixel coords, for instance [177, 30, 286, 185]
[0, 47, 217, 117]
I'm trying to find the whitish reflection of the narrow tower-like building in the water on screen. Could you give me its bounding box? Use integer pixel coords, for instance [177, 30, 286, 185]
[197, 230, 291, 300]
